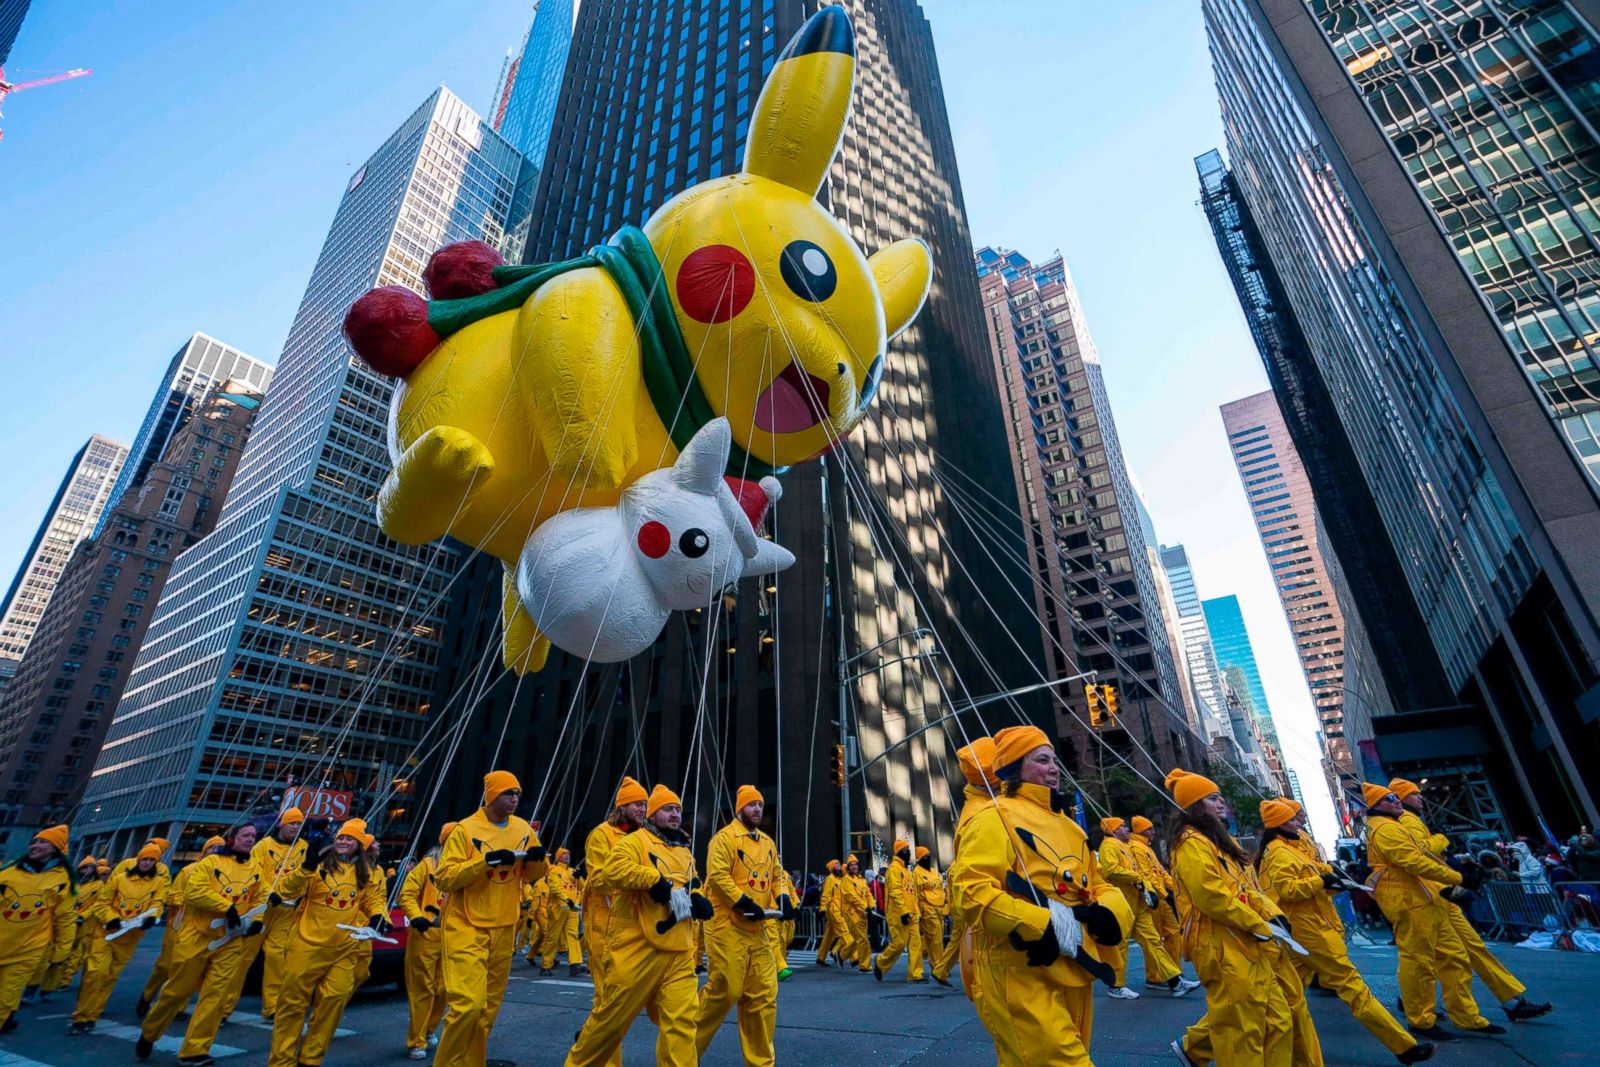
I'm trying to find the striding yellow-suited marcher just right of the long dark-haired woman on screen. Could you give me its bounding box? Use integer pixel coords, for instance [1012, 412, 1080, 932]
[1256, 798, 1434, 1064]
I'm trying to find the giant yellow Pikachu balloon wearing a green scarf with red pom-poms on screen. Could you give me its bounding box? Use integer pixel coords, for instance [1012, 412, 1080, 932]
[344, 6, 933, 673]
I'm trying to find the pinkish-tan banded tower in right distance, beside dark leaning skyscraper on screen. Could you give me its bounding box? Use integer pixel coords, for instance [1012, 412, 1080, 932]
[1222, 392, 1360, 774]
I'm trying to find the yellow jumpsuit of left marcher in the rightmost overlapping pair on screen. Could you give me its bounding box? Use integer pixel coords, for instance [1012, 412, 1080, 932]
[1366, 813, 1488, 1030]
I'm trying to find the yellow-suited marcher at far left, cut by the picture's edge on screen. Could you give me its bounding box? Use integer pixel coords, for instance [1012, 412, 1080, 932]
[0, 825, 77, 1033]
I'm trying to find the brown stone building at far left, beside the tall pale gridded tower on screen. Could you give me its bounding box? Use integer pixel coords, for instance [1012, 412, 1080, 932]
[0, 382, 261, 856]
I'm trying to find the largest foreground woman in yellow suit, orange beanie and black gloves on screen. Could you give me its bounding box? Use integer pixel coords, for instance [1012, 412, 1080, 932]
[950, 726, 1133, 1067]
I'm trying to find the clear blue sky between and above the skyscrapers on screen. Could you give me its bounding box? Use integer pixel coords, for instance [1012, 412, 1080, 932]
[0, 0, 1331, 835]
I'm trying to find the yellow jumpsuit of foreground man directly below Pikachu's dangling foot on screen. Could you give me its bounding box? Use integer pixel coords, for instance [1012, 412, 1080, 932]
[434, 808, 547, 1067]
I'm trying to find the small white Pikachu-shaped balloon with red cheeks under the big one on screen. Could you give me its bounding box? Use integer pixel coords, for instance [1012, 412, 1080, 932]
[517, 419, 795, 664]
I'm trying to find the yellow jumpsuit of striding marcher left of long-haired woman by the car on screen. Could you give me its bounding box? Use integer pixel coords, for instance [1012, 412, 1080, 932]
[141, 853, 267, 1056]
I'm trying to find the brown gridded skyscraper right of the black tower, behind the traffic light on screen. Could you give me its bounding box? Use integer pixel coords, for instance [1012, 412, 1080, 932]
[976, 246, 1203, 779]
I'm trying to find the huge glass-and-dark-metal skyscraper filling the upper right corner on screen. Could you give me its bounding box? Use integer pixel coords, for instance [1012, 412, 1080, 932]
[1205, 0, 1600, 827]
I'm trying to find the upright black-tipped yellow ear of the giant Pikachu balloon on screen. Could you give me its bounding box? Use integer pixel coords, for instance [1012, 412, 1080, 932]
[744, 3, 856, 195]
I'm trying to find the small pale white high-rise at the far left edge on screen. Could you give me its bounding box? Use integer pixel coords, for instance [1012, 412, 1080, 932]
[0, 434, 128, 661]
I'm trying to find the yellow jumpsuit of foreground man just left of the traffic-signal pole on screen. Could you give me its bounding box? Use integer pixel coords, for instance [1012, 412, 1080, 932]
[694, 819, 782, 1067]
